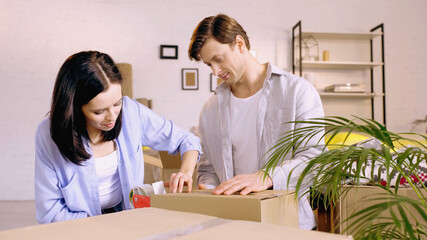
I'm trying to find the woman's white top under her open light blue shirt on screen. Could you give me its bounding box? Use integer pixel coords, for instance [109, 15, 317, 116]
[95, 151, 122, 209]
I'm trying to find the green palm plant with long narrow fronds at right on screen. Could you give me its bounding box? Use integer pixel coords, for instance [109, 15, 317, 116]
[264, 117, 427, 239]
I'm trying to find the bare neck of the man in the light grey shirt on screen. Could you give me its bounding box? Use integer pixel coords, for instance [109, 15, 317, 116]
[231, 56, 267, 98]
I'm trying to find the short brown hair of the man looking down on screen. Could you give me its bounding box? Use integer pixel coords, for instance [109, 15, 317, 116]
[188, 14, 251, 61]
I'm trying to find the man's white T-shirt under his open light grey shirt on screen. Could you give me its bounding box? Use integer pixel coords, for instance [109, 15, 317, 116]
[230, 89, 262, 175]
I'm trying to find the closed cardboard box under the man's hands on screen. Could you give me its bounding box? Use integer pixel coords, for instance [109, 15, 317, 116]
[151, 190, 298, 227]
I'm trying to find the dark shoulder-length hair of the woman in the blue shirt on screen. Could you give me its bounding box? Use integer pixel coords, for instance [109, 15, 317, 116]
[50, 51, 122, 165]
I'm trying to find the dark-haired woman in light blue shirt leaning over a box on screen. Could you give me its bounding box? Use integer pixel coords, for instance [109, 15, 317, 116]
[35, 51, 201, 223]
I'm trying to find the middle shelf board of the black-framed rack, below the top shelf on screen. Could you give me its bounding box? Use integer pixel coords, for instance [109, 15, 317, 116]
[296, 61, 384, 69]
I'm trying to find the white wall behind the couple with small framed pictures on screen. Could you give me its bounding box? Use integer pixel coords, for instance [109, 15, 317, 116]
[0, 0, 427, 200]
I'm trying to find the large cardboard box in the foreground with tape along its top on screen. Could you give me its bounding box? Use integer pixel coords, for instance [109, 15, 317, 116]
[0, 208, 351, 240]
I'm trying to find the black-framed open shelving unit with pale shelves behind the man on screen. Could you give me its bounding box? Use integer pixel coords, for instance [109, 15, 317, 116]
[292, 21, 386, 125]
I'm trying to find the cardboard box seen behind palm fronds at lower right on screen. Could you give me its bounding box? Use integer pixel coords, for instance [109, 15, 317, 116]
[334, 186, 421, 234]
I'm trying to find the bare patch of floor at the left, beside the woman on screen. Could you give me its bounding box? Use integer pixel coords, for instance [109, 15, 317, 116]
[0, 201, 38, 231]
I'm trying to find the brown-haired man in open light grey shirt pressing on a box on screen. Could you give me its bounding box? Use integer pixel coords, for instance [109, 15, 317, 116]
[188, 14, 323, 229]
